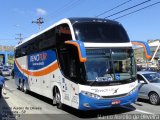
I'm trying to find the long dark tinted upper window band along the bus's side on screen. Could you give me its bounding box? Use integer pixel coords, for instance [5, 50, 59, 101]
[15, 24, 72, 58]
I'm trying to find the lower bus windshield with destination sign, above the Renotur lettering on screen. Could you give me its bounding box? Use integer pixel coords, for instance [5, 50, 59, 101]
[85, 48, 136, 82]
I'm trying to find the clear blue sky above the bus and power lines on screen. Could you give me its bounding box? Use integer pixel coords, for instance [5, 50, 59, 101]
[0, 0, 160, 46]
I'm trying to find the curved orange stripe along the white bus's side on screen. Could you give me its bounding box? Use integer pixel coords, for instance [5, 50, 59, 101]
[15, 60, 58, 76]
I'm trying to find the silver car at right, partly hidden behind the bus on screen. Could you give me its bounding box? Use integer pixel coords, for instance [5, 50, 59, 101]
[137, 71, 160, 105]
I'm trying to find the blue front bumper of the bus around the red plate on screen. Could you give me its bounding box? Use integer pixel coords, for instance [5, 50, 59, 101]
[79, 90, 138, 110]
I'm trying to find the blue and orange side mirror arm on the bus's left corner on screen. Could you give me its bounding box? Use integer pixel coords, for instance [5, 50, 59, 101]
[65, 40, 87, 62]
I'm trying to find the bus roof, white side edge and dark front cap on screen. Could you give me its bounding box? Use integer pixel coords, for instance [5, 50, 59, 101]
[15, 17, 120, 48]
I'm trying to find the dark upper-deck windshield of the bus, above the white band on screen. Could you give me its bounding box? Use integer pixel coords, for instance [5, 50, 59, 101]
[73, 22, 129, 43]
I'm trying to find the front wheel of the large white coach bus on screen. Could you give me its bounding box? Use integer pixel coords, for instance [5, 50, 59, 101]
[55, 89, 63, 109]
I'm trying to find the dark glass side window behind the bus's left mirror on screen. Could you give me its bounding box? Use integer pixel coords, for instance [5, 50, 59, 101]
[58, 45, 83, 82]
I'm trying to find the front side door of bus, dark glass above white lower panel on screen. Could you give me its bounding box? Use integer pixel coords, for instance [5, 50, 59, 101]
[58, 42, 85, 107]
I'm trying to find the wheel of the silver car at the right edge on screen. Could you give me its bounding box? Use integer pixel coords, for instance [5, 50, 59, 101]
[149, 92, 160, 105]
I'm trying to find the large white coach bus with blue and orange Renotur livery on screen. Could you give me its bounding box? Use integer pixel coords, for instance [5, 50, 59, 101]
[14, 18, 138, 110]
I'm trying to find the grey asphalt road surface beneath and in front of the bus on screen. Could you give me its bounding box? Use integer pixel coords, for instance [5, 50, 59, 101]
[0, 77, 160, 120]
